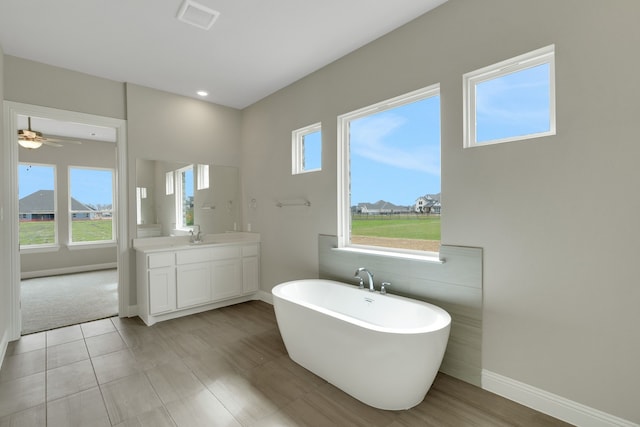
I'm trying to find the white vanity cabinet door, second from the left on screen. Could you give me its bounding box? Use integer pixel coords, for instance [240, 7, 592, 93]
[177, 262, 211, 308]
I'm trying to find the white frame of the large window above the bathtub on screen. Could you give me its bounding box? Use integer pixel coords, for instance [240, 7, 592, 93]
[336, 83, 444, 263]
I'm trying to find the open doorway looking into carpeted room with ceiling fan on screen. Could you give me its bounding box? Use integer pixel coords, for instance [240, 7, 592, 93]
[18, 129, 118, 335]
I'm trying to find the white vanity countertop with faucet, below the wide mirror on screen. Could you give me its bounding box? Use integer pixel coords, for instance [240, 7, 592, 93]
[133, 232, 260, 253]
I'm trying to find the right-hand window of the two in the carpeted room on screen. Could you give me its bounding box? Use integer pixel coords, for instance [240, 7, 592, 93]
[69, 167, 115, 243]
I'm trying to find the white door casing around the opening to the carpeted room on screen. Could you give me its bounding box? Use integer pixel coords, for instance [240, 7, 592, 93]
[3, 101, 129, 339]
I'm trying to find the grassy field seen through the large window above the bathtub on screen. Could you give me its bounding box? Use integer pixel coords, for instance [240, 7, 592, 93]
[351, 215, 440, 240]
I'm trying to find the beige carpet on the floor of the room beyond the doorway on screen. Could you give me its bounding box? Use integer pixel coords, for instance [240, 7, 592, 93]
[20, 269, 118, 334]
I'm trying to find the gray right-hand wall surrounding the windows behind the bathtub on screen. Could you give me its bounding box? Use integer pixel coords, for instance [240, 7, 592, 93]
[242, 0, 640, 422]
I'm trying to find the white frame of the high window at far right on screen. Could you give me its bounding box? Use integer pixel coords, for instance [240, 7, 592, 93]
[462, 44, 556, 148]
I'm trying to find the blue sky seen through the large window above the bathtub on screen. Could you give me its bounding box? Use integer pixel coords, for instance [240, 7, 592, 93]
[350, 96, 440, 206]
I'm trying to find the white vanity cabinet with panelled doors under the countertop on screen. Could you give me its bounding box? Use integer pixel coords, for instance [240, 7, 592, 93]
[134, 236, 260, 325]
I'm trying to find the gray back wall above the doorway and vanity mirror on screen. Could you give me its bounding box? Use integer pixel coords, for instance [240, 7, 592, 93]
[3, 67, 241, 298]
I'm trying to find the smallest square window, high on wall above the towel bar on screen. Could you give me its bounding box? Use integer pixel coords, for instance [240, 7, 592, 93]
[291, 123, 322, 175]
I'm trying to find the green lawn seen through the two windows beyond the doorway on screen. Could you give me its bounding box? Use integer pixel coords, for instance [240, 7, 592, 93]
[20, 219, 113, 245]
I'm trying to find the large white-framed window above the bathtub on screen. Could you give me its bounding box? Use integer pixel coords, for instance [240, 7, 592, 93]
[338, 85, 441, 252]
